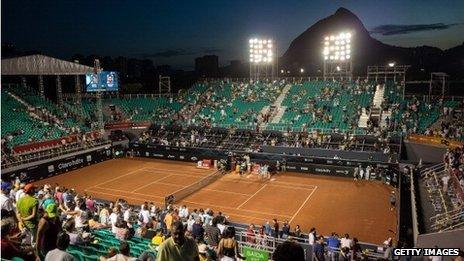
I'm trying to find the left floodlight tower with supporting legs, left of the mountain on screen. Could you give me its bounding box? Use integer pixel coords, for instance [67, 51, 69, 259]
[248, 38, 277, 80]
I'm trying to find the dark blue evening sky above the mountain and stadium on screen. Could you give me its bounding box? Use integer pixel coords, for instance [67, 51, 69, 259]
[2, 0, 464, 69]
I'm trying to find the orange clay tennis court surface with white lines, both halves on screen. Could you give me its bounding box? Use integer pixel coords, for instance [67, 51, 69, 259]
[38, 158, 397, 244]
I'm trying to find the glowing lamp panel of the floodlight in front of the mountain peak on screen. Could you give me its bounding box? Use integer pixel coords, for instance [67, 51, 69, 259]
[322, 32, 351, 61]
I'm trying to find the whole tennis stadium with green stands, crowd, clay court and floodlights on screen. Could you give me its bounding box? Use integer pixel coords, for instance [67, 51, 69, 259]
[1, 6, 464, 261]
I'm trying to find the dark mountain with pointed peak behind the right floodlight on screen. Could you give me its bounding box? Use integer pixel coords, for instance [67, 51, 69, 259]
[279, 8, 464, 78]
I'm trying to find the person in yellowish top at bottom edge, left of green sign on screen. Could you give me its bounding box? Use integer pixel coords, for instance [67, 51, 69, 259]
[156, 222, 200, 261]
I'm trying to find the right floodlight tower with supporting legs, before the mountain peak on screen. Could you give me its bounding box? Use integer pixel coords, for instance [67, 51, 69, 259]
[322, 31, 353, 80]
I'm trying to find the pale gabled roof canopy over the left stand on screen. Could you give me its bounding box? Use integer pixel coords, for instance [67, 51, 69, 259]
[2, 54, 93, 75]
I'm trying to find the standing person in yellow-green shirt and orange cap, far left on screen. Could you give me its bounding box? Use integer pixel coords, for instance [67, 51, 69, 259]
[16, 184, 39, 243]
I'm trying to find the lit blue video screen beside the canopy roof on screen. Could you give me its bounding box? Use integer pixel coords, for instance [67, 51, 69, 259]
[85, 71, 119, 92]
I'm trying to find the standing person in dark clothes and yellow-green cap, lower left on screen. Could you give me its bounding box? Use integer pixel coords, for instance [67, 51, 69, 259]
[36, 203, 61, 258]
